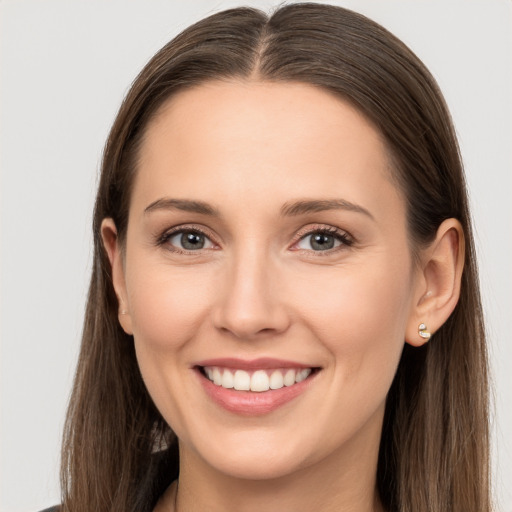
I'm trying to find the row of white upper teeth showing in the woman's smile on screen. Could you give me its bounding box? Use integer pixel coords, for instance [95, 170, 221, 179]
[204, 366, 312, 393]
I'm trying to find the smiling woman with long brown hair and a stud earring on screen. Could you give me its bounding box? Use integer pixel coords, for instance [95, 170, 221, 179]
[51, 4, 490, 512]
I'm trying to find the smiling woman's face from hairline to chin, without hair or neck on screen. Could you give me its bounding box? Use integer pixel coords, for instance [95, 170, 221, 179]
[110, 82, 418, 479]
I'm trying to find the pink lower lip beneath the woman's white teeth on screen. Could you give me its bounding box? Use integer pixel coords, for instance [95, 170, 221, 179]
[195, 369, 318, 416]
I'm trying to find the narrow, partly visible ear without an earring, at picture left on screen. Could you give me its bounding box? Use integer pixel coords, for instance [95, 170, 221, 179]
[101, 218, 133, 334]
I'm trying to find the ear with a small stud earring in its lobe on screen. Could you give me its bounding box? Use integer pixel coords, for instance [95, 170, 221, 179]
[405, 219, 465, 346]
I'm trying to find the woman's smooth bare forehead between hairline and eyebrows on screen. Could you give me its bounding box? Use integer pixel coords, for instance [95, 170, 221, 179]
[134, 81, 404, 222]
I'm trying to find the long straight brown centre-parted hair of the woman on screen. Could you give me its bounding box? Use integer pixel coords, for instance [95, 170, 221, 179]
[62, 3, 491, 512]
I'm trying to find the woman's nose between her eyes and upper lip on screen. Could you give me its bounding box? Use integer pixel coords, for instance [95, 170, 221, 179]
[213, 251, 290, 340]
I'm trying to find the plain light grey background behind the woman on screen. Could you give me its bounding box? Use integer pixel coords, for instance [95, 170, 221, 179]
[0, 0, 512, 512]
